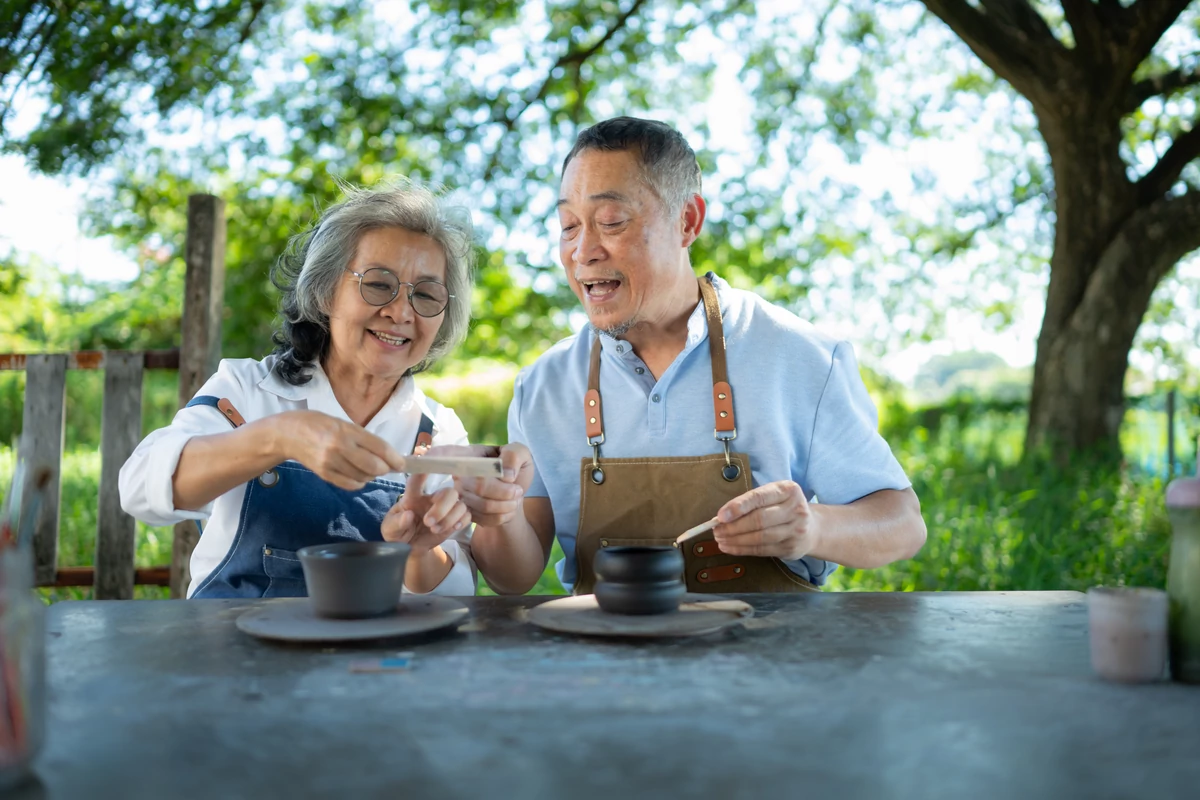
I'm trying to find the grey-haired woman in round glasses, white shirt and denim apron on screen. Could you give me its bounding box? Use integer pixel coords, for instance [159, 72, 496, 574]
[120, 184, 475, 597]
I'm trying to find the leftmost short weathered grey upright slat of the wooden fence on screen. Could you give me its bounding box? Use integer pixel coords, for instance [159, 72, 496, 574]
[20, 355, 67, 587]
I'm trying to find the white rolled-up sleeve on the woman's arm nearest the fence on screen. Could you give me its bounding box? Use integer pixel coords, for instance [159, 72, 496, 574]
[118, 361, 247, 525]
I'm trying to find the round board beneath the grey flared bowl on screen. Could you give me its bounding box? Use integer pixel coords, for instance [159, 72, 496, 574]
[238, 595, 469, 642]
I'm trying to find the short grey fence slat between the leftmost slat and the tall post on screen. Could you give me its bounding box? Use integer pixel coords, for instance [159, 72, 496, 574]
[92, 351, 145, 600]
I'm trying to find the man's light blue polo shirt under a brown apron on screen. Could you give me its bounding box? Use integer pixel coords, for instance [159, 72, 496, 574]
[509, 272, 911, 590]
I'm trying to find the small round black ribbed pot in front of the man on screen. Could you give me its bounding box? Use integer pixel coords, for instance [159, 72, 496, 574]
[595, 547, 686, 614]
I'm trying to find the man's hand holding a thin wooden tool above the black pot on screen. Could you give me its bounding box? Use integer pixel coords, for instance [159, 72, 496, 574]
[713, 481, 818, 560]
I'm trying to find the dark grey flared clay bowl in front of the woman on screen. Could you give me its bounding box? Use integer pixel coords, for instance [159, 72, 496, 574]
[296, 542, 412, 619]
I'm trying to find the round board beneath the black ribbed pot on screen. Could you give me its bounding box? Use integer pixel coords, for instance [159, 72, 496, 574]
[526, 595, 754, 637]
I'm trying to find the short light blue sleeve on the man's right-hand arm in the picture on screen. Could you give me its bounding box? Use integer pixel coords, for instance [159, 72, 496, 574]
[799, 342, 911, 504]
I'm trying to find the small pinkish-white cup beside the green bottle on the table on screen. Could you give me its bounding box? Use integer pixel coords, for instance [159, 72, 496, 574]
[1087, 587, 1168, 684]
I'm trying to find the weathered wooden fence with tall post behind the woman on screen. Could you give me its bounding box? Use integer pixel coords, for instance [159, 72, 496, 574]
[0, 194, 226, 600]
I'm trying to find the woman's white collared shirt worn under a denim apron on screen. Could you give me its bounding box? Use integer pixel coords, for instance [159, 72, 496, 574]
[119, 355, 475, 596]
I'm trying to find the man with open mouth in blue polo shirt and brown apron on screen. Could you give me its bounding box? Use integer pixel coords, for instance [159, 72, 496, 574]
[460, 116, 925, 594]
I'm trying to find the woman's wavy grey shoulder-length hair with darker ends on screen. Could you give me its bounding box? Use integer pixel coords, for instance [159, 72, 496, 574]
[271, 180, 475, 385]
